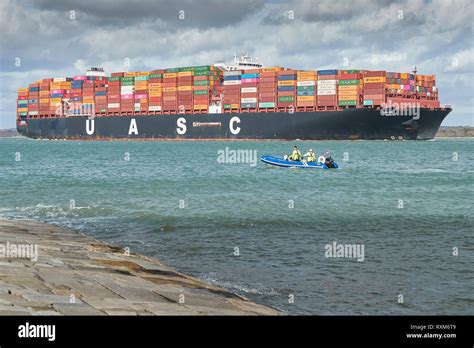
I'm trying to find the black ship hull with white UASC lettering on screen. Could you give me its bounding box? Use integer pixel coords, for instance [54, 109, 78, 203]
[17, 108, 451, 140]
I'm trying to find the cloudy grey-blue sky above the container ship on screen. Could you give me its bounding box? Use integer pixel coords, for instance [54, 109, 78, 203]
[0, 0, 474, 129]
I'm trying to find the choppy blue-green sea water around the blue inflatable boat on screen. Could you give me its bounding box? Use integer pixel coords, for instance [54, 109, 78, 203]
[0, 138, 474, 315]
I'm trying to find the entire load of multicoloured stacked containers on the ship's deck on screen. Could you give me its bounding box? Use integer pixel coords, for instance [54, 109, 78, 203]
[17, 65, 439, 119]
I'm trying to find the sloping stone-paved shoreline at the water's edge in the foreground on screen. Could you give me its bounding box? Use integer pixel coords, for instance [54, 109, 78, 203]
[0, 220, 281, 315]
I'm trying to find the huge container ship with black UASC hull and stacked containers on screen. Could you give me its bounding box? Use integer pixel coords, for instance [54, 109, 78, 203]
[17, 54, 451, 140]
